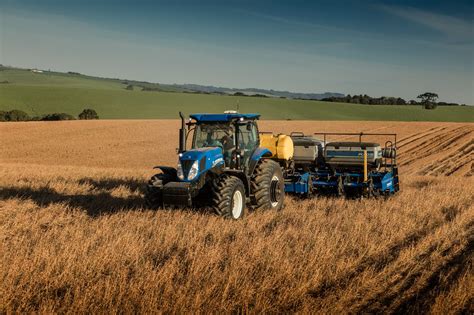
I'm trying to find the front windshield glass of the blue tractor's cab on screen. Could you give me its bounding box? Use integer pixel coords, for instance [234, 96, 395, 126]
[193, 123, 235, 150]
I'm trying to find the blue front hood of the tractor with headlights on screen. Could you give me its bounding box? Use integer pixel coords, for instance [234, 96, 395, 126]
[178, 147, 224, 181]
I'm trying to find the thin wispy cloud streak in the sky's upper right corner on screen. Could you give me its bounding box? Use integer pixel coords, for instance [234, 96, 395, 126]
[377, 5, 473, 40]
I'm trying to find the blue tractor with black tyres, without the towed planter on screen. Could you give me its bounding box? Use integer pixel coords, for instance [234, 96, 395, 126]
[145, 111, 285, 219]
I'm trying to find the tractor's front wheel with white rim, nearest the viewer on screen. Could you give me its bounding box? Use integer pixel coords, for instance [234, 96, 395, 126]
[211, 175, 246, 220]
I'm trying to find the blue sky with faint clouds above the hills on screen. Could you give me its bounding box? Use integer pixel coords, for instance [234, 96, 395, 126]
[0, 0, 474, 104]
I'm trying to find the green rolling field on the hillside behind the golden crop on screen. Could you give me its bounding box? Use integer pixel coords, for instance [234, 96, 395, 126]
[0, 68, 474, 122]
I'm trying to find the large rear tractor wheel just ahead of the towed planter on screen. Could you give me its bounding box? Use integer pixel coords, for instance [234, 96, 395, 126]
[251, 160, 285, 210]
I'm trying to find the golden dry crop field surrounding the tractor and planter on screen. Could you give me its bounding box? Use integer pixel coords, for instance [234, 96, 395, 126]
[0, 120, 474, 314]
